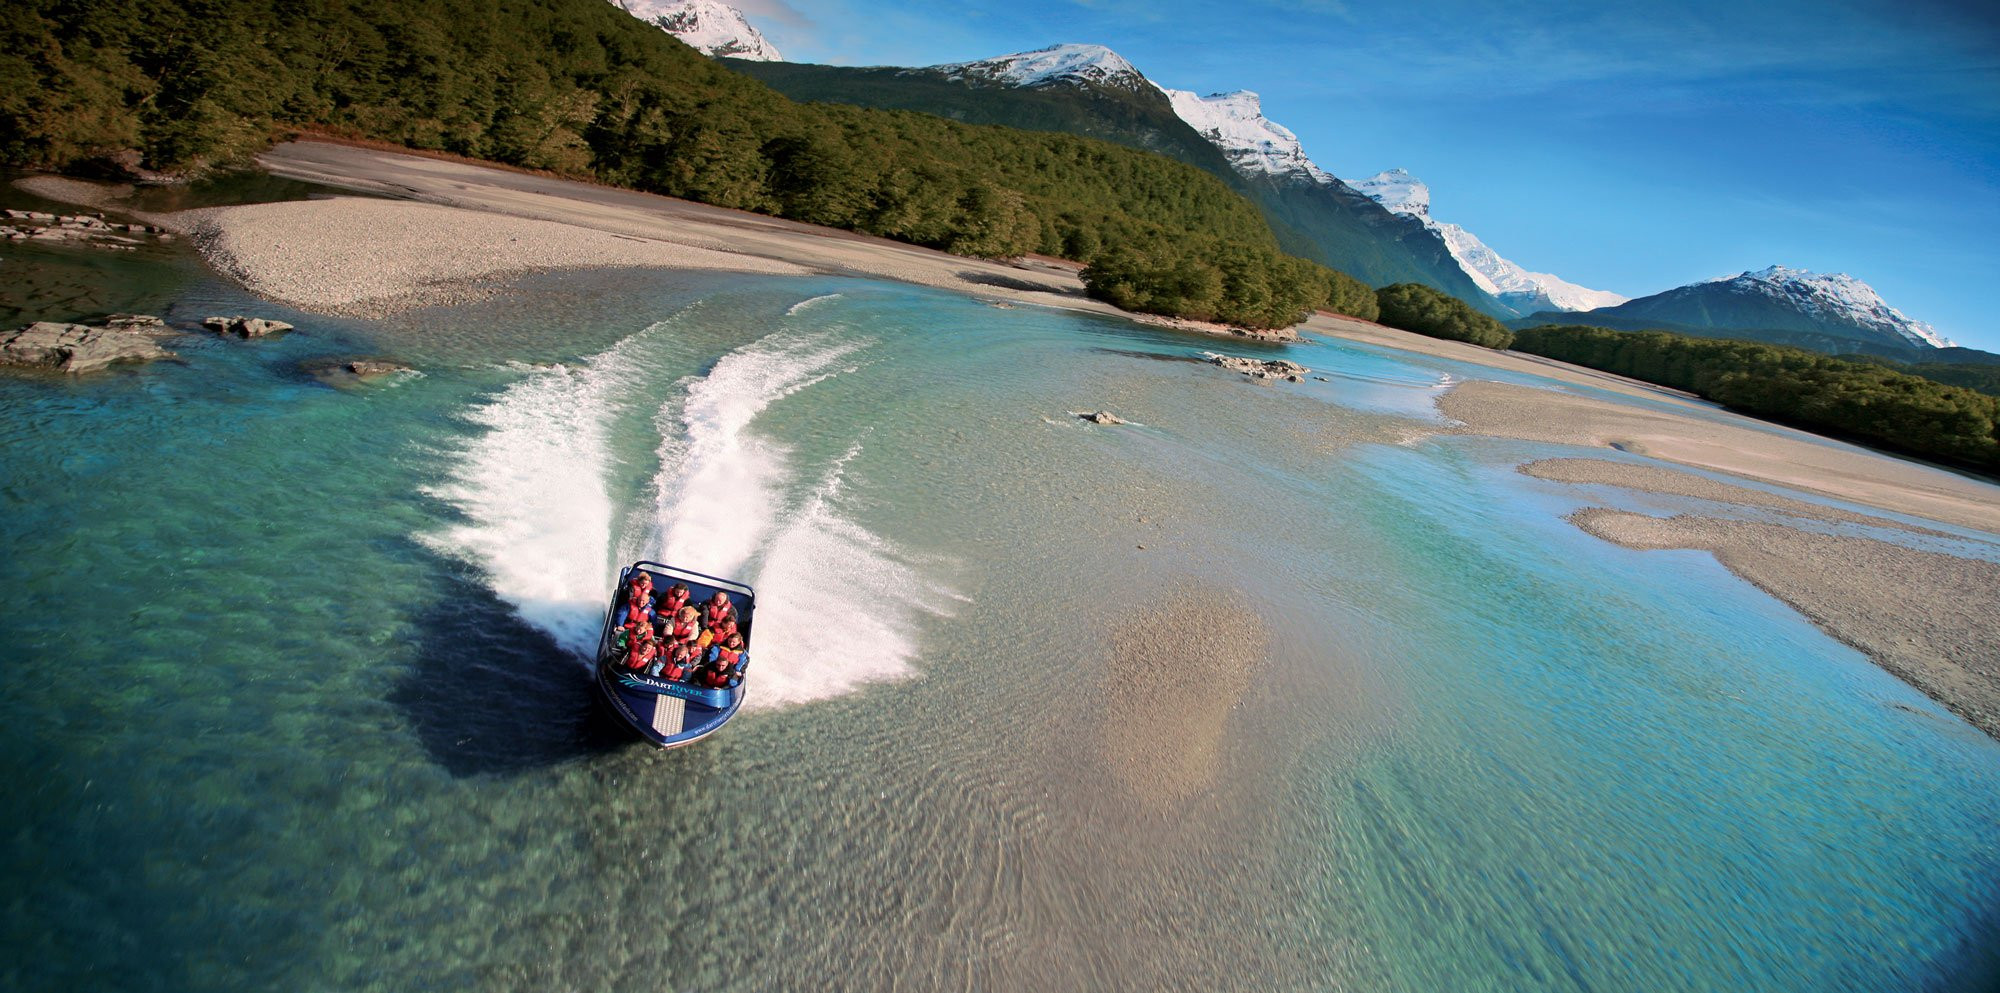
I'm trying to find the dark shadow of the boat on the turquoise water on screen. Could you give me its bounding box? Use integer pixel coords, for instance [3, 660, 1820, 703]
[388, 563, 632, 777]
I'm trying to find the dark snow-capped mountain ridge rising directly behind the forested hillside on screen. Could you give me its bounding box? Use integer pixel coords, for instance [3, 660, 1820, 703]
[744, 44, 1516, 316]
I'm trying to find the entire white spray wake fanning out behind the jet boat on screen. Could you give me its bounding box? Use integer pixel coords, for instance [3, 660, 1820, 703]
[426, 314, 956, 707]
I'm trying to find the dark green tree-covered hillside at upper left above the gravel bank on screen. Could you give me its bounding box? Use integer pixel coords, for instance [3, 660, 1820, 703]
[0, 0, 1376, 320]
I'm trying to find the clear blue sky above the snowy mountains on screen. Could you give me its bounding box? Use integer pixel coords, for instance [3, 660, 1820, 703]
[738, 0, 2000, 350]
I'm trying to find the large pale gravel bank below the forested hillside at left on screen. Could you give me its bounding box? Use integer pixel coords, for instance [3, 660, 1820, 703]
[186, 140, 1152, 322]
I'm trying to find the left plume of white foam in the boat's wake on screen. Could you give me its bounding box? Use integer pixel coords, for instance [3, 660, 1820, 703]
[424, 322, 664, 655]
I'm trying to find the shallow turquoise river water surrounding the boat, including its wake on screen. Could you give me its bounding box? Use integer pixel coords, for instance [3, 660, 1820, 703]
[0, 238, 2000, 991]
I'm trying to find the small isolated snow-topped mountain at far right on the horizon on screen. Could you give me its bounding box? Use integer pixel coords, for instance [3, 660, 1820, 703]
[1522, 266, 1956, 358]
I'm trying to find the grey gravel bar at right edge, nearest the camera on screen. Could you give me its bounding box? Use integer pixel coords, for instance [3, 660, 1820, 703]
[1570, 507, 2000, 739]
